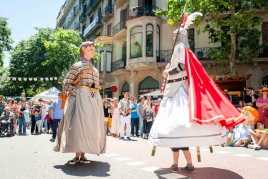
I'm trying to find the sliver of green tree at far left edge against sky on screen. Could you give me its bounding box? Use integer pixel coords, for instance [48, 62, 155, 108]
[0, 16, 13, 66]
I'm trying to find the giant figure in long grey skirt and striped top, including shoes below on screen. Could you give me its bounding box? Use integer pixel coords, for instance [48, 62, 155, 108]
[54, 41, 106, 164]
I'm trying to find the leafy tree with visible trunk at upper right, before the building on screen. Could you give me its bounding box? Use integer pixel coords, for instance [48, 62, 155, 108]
[157, 0, 268, 74]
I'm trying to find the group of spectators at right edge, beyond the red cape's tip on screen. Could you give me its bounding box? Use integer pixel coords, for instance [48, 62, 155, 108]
[226, 87, 268, 150]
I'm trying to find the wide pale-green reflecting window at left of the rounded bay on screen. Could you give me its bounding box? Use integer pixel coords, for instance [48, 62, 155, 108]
[130, 26, 143, 58]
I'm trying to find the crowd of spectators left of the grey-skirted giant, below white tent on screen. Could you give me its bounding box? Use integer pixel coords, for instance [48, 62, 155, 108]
[0, 93, 63, 140]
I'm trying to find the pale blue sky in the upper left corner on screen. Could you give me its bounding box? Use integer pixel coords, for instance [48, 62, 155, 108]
[0, 0, 65, 67]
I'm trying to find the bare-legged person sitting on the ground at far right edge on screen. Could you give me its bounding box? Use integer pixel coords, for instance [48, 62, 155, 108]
[249, 121, 268, 150]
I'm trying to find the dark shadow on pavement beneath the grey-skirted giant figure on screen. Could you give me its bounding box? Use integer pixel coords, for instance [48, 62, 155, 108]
[54, 161, 110, 177]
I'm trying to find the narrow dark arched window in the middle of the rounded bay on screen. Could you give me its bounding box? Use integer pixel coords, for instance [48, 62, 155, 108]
[146, 24, 154, 57]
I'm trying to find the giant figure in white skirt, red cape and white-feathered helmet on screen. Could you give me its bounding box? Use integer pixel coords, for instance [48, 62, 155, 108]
[149, 12, 244, 152]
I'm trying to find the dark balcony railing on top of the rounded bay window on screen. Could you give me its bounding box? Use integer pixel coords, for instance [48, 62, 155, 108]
[129, 6, 161, 19]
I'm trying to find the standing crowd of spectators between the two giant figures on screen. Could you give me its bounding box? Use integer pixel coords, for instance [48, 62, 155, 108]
[103, 93, 161, 140]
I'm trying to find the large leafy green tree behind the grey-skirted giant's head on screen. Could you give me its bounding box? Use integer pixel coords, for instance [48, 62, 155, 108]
[9, 28, 81, 96]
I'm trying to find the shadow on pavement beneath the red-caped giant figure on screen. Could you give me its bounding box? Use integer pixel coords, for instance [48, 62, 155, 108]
[154, 167, 243, 179]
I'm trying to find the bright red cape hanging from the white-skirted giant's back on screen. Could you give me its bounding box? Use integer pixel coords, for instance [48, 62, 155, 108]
[185, 48, 245, 128]
